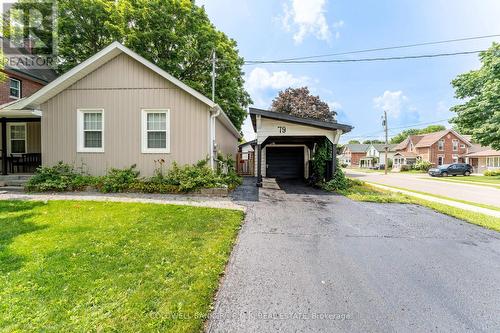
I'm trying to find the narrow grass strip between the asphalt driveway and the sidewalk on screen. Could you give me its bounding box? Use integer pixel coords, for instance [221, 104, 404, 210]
[341, 183, 500, 231]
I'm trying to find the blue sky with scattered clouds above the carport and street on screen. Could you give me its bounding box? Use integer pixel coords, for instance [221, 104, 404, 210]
[197, 0, 500, 142]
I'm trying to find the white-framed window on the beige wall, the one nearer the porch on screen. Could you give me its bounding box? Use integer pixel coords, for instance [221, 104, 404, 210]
[77, 109, 104, 153]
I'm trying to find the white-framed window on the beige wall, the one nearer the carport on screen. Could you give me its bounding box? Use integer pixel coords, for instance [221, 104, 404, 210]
[142, 109, 170, 154]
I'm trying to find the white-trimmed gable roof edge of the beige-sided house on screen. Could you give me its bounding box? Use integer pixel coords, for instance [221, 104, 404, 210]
[5, 42, 241, 138]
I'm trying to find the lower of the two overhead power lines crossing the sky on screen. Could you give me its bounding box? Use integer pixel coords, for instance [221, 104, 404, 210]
[245, 50, 484, 65]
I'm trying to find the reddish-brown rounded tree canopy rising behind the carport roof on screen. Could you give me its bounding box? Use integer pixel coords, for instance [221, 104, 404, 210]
[271, 87, 336, 121]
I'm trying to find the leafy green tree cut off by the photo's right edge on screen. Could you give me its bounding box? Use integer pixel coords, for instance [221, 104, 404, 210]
[451, 43, 500, 150]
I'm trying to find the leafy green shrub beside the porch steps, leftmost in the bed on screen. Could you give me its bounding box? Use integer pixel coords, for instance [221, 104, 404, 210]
[25, 162, 98, 192]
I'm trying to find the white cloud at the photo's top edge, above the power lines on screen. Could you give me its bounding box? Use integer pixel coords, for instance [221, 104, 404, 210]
[281, 0, 332, 44]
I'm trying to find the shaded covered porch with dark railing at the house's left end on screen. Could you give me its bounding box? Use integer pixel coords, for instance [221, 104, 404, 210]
[0, 110, 42, 176]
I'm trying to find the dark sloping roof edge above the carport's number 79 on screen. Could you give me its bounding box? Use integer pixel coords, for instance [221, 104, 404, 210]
[249, 108, 353, 133]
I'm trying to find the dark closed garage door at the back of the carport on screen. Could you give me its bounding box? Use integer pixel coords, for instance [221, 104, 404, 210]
[266, 147, 304, 179]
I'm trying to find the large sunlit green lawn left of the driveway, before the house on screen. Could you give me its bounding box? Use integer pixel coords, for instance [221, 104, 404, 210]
[0, 201, 243, 332]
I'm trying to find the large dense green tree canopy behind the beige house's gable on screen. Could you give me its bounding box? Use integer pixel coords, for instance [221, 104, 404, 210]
[18, 0, 251, 129]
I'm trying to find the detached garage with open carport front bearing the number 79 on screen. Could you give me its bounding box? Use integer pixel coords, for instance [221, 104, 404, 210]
[250, 108, 352, 186]
